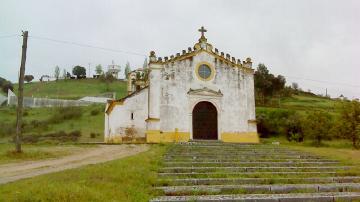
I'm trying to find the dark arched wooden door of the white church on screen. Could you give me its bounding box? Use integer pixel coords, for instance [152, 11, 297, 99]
[192, 101, 218, 140]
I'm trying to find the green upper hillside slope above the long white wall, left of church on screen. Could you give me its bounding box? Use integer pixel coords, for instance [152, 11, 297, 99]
[14, 79, 126, 99]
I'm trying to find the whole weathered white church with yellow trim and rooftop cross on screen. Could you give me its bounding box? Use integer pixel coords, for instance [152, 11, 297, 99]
[104, 27, 259, 143]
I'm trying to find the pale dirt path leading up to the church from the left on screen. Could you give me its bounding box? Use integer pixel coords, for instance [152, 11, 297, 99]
[0, 145, 149, 184]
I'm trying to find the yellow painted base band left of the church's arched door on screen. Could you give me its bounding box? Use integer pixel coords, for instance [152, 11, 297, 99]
[146, 130, 190, 143]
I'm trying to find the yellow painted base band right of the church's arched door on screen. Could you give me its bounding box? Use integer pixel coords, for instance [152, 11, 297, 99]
[221, 132, 260, 143]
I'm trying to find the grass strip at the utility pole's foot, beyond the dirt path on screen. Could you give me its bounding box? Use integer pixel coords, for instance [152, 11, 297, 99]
[0, 144, 94, 164]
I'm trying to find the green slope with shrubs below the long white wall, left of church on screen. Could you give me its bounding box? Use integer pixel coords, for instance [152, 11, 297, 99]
[0, 105, 105, 142]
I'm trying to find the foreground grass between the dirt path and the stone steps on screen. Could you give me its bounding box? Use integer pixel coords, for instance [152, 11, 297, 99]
[0, 145, 167, 202]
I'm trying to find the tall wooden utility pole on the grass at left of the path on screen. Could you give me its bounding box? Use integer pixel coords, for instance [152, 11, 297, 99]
[15, 31, 28, 153]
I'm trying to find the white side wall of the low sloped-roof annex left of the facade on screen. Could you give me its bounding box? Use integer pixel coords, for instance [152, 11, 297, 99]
[105, 89, 148, 142]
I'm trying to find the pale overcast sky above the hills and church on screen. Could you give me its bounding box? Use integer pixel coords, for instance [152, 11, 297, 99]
[0, 0, 360, 98]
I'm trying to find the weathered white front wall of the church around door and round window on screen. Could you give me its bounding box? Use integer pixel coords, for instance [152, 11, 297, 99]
[160, 52, 256, 135]
